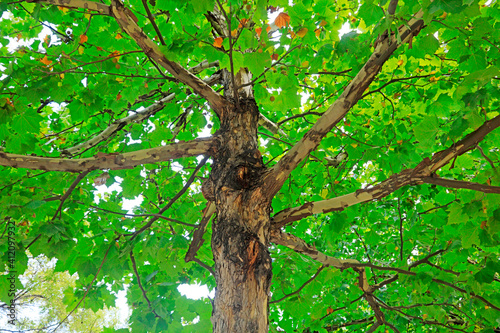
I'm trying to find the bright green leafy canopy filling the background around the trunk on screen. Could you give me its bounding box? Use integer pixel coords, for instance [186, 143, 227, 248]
[0, 0, 500, 332]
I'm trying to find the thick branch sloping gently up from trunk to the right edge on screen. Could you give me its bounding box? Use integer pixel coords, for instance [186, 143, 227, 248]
[273, 116, 500, 228]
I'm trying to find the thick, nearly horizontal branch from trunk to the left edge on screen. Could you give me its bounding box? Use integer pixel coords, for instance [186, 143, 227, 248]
[0, 138, 212, 172]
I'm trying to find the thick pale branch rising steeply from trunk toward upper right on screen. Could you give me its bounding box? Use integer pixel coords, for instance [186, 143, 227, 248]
[265, 11, 423, 198]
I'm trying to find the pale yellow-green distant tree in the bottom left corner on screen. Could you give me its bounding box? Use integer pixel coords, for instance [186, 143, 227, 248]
[0, 255, 119, 332]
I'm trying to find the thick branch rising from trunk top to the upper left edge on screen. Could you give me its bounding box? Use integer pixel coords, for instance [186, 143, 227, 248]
[109, 0, 228, 112]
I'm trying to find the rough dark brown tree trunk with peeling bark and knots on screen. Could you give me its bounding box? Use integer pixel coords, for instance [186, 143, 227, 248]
[203, 98, 272, 333]
